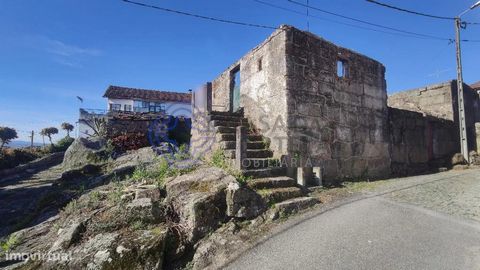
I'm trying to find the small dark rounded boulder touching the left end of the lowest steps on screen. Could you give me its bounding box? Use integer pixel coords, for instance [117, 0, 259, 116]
[226, 182, 266, 219]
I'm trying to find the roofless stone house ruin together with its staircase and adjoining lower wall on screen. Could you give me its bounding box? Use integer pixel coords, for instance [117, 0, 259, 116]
[192, 25, 474, 184]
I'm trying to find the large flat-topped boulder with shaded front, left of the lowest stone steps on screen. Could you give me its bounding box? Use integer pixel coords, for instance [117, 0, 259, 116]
[166, 167, 237, 242]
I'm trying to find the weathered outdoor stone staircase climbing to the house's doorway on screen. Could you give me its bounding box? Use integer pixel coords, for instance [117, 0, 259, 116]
[210, 112, 318, 214]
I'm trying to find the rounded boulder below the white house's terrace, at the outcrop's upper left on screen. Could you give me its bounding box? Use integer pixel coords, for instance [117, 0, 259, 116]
[62, 137, 106, 170]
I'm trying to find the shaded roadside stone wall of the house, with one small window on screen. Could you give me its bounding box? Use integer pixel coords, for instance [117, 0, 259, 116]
[286, 28, 390, 180]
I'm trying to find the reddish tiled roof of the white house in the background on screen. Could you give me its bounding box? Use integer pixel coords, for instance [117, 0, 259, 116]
[103, 85, 192, 103]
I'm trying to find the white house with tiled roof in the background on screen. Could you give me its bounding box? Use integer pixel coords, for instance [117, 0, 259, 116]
[103, 86, 192, 118]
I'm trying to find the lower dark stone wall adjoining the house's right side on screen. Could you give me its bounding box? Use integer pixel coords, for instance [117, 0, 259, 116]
[389, 108, 460, 176]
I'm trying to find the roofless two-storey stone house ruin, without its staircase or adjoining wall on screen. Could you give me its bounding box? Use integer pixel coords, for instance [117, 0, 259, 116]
[192, 26, 390, 184]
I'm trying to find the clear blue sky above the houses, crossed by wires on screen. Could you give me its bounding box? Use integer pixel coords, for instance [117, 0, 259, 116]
[0, 0, 480, 141]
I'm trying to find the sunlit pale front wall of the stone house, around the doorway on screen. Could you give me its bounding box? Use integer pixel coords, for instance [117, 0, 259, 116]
[212, 26, 289, 157]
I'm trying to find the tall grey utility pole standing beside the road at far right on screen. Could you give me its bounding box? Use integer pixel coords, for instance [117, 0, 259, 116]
[455, 17, 470, 163]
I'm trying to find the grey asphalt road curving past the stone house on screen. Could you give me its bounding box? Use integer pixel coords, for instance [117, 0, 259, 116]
[227, 171, 480, 270]
